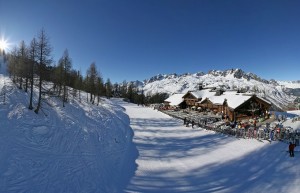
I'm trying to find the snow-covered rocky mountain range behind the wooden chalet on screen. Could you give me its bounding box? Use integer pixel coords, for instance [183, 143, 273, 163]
[135, 69, 300, 109]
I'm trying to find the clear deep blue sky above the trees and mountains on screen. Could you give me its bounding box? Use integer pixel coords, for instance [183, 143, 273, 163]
[0, 0, 300, 82]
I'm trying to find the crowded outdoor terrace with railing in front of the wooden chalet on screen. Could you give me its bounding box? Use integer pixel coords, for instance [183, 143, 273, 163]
[161, 107, 300, 145]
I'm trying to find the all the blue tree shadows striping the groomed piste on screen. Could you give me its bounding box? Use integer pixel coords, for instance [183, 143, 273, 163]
[121, 119, 300, 193]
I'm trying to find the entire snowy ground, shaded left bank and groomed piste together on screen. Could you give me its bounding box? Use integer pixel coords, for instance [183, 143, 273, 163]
[0, 54, 300, 193]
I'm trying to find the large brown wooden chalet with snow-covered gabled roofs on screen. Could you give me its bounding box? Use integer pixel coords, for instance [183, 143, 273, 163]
[178, 89, 271, 121]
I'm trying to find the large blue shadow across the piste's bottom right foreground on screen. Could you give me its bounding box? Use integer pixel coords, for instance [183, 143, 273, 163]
[122, 138, 299, 193]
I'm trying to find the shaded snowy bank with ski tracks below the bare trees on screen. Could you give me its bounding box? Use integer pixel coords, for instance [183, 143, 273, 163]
[0, 62, 137, 193]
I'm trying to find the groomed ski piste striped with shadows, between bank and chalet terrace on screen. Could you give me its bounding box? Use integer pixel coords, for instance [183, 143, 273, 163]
[120, 102, 300, 193]
